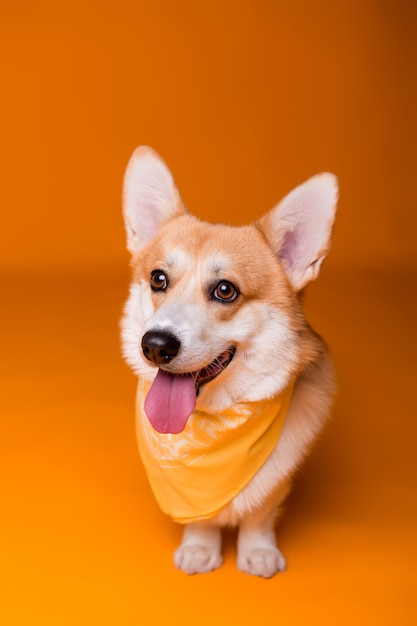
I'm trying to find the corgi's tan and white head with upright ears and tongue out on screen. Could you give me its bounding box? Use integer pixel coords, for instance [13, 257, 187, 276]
[122, 148, 337, 432]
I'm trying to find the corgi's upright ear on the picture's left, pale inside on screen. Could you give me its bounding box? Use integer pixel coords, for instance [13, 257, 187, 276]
[123, 146, 186, 254]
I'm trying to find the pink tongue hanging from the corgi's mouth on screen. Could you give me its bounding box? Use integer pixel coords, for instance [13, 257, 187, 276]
[145, 369, 197, 434]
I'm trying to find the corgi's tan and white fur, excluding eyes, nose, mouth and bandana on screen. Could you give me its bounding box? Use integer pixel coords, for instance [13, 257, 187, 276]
[118, 148, 337, 577]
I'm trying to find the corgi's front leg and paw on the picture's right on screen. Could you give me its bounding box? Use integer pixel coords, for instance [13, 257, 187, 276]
[237, 480, 291, 578]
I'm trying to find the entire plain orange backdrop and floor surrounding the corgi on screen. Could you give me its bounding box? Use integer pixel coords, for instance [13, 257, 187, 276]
[0, 0, 417, 625]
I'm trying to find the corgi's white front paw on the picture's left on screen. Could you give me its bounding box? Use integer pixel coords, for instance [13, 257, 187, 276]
[174, 521, 223, 574]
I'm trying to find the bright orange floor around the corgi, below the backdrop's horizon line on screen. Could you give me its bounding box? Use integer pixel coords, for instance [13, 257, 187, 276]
[0, 268, 417, 626]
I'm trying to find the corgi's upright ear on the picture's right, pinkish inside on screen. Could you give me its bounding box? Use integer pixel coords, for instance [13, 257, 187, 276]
[256, 172, 338, 291]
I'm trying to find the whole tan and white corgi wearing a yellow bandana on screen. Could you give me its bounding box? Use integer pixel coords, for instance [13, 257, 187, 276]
[121, 146, 338, 578]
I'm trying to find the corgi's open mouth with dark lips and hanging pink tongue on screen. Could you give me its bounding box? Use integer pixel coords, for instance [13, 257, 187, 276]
[144, 346, 236, 434]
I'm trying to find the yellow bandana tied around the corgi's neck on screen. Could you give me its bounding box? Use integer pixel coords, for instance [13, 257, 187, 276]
[136, 379, 294, 524]
